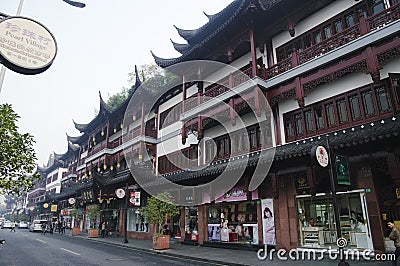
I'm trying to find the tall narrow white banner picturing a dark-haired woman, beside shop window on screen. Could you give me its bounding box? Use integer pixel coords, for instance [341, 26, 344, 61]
[261, 199, 276, 245]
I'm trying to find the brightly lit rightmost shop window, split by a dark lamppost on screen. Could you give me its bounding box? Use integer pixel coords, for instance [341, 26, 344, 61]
[297, 191, 373, 249]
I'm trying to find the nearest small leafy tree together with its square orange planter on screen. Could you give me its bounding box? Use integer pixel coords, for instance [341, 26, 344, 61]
[143, 192, 180, 249]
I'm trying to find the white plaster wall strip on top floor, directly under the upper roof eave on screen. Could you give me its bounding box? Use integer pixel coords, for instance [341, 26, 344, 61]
[272, 0, 358, 62]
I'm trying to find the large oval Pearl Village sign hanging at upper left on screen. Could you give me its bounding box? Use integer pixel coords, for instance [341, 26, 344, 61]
[0, 17, 57, 75]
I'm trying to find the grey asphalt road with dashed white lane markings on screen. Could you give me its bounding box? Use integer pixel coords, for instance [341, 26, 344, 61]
[0, 229, 223, 266]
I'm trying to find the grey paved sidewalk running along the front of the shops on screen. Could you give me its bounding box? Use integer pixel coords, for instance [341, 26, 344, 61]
[71, 232, 391, 266]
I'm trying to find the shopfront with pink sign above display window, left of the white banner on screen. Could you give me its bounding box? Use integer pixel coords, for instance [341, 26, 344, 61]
[207, 187, 260, 245]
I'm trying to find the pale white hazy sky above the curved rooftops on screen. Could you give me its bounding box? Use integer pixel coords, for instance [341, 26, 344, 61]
[0, 0, 232, 165]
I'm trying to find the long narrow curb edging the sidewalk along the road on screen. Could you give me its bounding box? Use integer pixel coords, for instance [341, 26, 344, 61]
[69, 235, 251, 266]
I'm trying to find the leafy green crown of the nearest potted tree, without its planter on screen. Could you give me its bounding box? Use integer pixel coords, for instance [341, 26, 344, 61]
[143, 192, 180, 235]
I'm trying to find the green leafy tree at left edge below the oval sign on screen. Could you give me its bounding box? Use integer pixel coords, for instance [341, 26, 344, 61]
[0, 104, 40, 194]
